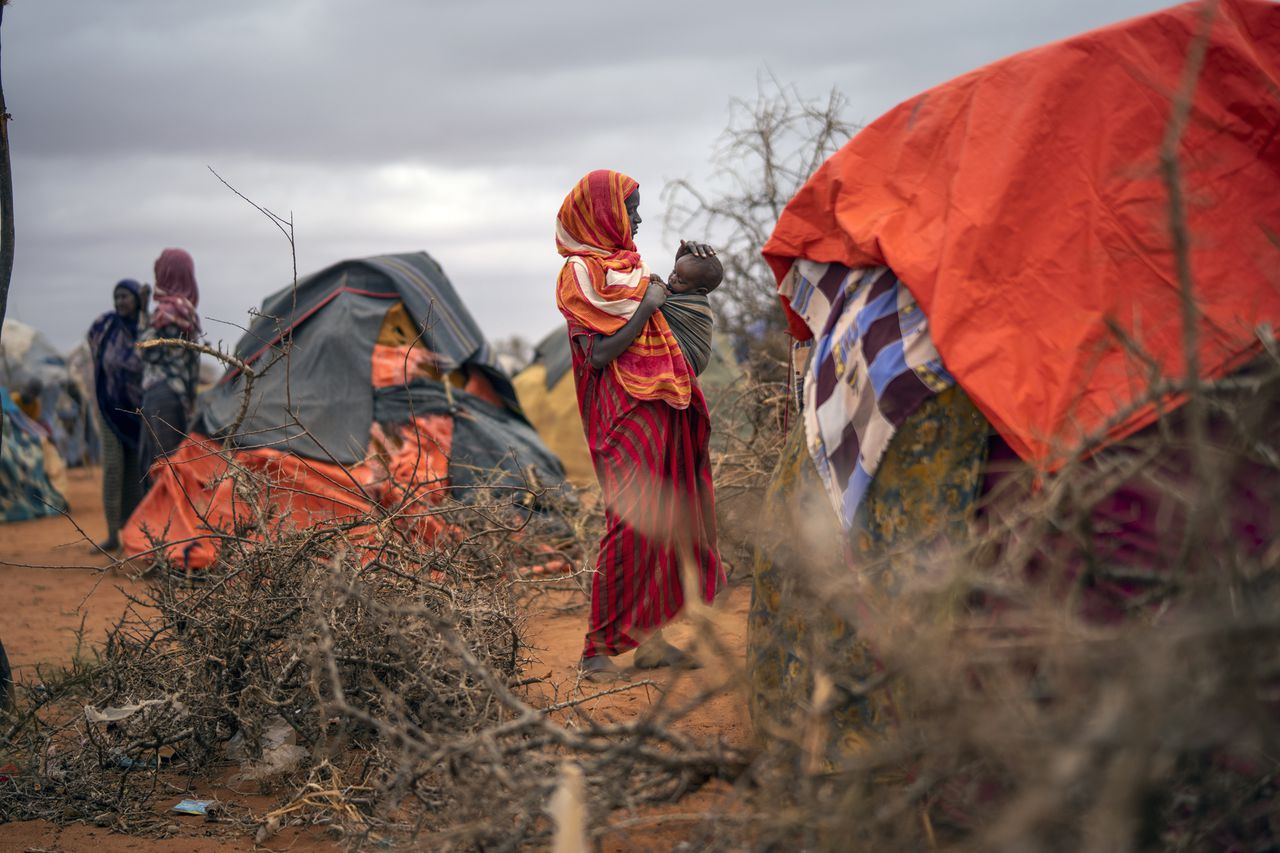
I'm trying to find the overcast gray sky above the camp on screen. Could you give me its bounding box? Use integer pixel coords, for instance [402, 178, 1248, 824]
[0, 0, 1170, 348]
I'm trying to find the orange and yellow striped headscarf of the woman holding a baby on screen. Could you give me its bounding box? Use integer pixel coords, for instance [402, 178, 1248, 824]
[556, 169, 692, 409]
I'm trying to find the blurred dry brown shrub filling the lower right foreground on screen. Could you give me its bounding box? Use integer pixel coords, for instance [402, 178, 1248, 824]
[727, 357, 1280, 850]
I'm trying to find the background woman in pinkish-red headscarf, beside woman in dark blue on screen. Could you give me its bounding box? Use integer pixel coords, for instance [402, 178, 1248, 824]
[138, 248, 201, 481]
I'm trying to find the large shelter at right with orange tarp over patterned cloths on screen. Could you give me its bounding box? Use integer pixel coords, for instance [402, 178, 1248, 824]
[749, 0, 1280, 761]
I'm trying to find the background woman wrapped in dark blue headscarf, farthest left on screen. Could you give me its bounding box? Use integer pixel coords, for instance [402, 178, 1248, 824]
[88, 278, 146, 551]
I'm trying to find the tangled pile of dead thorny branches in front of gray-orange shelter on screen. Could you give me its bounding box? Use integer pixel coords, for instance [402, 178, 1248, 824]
[0, 461, 745, 849]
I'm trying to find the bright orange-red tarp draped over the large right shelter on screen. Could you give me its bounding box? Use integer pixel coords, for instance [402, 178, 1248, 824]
[764, 0, 1280, 465]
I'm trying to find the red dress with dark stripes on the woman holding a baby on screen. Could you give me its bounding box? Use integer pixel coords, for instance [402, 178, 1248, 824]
[570, 324, 724, 657]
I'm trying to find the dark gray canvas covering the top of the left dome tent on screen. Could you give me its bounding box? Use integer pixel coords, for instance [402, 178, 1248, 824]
[195, 252, 564, 487]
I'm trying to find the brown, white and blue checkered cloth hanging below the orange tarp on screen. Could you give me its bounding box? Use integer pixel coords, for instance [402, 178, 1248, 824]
[778, 259, 955, 528]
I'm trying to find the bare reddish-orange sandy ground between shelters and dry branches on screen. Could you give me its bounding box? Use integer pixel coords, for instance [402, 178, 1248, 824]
[0, 469, 749, 853]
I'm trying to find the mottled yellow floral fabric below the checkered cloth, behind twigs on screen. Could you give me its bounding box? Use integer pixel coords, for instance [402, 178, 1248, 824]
[748, 388, 991, 768]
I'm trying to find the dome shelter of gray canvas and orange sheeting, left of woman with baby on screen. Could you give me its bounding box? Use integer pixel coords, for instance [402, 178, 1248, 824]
[123, 252, 564, 569]
